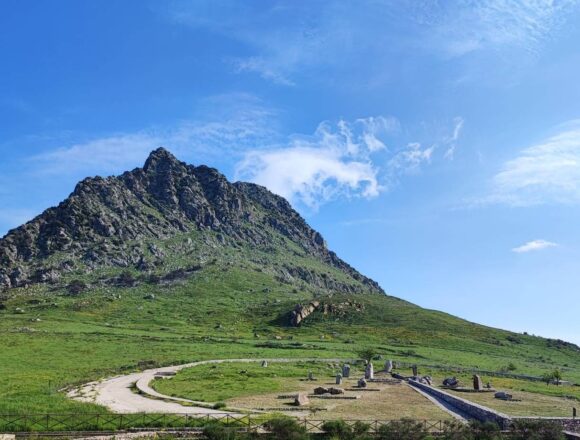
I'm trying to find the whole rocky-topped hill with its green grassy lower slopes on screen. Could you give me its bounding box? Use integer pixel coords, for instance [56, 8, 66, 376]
[0, 149, 580, 413]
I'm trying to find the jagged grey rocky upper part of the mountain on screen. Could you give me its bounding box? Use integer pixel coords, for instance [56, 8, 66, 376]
[0, 148, 382, 293]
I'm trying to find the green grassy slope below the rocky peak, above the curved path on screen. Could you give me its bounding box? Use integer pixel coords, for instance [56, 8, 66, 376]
[0, 235, 580, 413]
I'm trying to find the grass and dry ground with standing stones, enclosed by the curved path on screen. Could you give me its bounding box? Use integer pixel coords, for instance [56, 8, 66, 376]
[154, 362, 450, 420]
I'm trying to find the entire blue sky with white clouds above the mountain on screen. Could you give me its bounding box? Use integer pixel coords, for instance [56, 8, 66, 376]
[0, 0, 580, 343]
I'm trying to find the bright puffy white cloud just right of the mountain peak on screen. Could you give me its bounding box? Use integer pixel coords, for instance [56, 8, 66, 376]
[236, 117, 398, 208]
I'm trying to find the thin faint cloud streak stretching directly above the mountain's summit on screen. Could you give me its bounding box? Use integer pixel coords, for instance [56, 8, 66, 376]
[32, 94, 276, 175]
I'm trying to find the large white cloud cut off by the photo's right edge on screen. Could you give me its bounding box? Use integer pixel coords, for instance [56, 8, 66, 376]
[484, 124, 580, 206]
